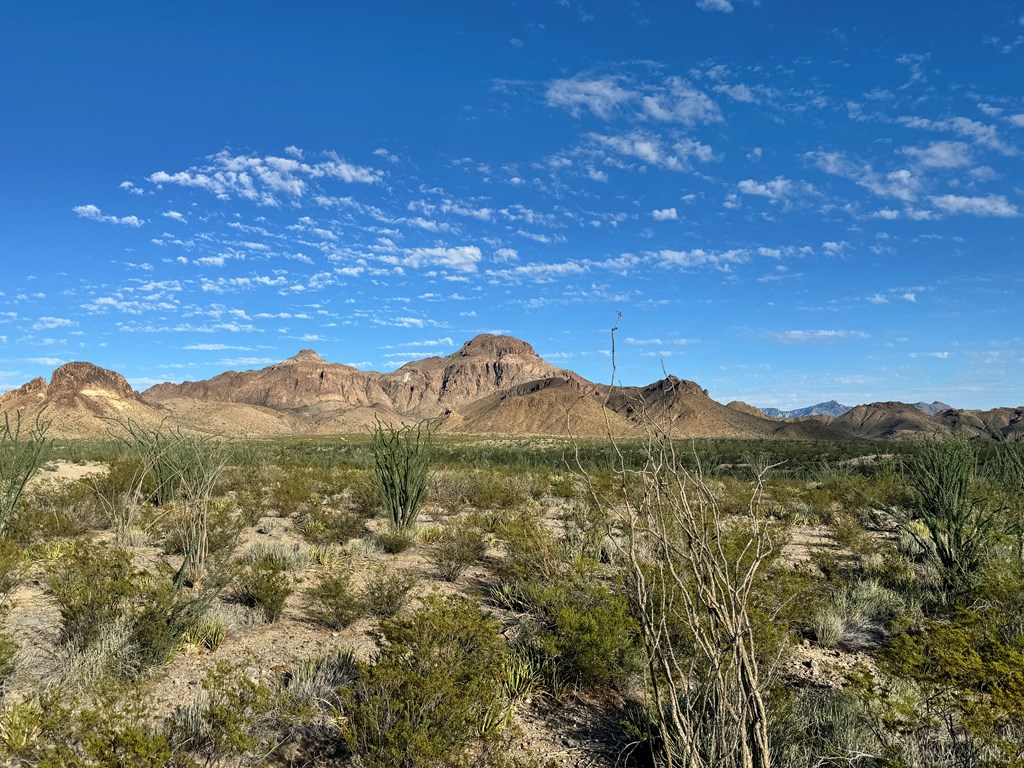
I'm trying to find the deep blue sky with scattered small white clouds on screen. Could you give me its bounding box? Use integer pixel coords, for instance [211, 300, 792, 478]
[0, 0, 1024, 408]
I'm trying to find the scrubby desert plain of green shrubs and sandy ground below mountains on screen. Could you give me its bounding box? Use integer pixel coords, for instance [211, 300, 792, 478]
[0, 423, 1024, 768]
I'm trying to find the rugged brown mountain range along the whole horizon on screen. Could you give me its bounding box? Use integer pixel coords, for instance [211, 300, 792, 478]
[0, 334, 1024, 440]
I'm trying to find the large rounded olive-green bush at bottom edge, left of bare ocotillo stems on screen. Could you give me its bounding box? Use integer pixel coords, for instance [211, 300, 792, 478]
[342, 598, 506, 768]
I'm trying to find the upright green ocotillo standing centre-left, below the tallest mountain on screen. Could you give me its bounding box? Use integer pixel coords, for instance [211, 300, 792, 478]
[371, 422, 433, 530]
